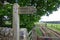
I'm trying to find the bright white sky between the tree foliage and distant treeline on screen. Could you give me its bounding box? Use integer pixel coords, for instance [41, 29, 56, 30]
[40, 8, 60, 21]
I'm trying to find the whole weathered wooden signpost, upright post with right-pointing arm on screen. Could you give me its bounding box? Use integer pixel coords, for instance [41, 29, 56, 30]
[13, 3, 36, 40]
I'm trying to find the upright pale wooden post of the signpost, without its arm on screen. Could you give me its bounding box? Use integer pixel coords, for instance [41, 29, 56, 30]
[13, 3, 19, 40]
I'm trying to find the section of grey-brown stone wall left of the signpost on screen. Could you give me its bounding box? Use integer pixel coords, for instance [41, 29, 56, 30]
[0, 27, 13, 40]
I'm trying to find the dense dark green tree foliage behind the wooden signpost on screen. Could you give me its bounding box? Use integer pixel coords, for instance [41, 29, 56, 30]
[0, 0, 60, 30]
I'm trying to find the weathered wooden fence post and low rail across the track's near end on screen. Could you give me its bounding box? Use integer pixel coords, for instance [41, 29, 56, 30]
[31, 30, 60, 40]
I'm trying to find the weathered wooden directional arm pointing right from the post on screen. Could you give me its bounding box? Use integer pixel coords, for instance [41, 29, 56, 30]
[19, 6, 36, 14]
